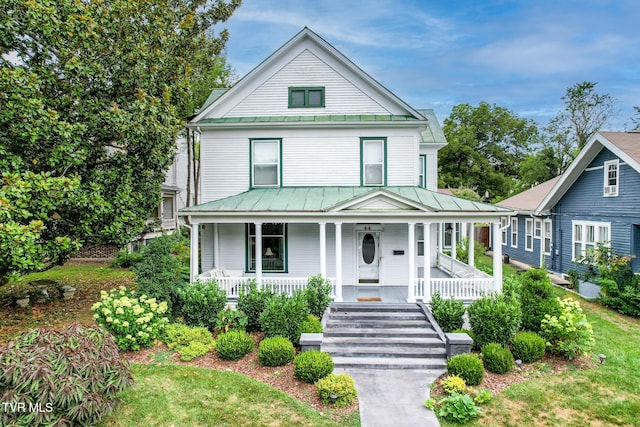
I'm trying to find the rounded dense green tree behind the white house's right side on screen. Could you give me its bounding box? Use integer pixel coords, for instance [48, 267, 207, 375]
[438, 102, 539, 199]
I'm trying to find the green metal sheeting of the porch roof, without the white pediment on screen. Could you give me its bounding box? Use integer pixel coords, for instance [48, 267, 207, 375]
[181, 187, 510, 214]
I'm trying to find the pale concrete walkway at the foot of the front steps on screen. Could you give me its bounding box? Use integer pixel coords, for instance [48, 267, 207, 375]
[346, 369, 444, 427]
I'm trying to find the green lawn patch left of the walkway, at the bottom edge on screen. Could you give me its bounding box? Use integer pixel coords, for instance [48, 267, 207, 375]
[101, 364, 360, 427]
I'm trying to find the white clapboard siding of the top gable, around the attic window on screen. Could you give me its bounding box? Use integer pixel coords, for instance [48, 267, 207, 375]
[224, 50, 390, 117]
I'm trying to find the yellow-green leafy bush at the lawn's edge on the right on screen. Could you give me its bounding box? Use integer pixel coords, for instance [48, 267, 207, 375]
[541, 298, 595, 360]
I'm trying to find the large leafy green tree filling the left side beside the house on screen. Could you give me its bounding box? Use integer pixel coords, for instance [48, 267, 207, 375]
[0, 0, 240, 283]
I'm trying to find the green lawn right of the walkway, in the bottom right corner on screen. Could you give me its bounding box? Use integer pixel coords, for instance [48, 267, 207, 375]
[442, 294, 640, 426]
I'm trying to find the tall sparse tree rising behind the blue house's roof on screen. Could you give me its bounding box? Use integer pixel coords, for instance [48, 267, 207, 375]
[545, 81, 615, 157]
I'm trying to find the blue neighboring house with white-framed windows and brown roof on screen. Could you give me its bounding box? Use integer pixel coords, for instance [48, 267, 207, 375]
[499, 132, 640, 274]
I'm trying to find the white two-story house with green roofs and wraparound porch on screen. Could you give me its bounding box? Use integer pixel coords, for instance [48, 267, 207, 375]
[181, 28, 509, 301]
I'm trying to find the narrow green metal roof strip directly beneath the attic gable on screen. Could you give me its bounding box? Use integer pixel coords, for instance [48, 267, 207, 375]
[197, 114, 419, 124]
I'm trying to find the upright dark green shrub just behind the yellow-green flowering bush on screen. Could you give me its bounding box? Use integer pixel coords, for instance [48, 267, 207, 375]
[520, 268, 560, 332]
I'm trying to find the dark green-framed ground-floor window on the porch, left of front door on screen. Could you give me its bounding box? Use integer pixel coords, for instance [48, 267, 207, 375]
[247, 223, 287, 272]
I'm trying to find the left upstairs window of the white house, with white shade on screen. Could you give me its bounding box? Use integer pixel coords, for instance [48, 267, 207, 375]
[250, 139, 282, 187]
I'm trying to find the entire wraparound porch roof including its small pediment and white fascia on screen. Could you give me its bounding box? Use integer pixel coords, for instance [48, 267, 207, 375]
[181, 186, 510, 216]
